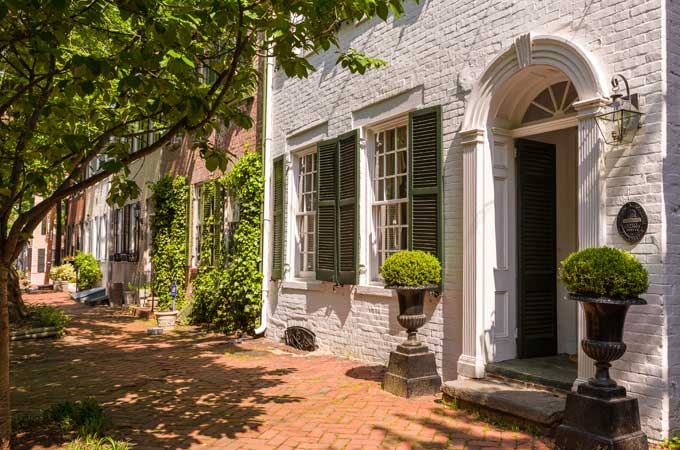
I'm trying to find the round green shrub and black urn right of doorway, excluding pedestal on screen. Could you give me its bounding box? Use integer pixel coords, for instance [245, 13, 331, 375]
[559, 247, 649, 390]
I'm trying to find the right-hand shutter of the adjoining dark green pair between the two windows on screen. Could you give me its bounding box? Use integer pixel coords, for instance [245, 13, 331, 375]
[337, 131, 359, 284]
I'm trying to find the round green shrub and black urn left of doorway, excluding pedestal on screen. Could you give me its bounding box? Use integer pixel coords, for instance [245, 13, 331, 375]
[380, 250, 442, 346]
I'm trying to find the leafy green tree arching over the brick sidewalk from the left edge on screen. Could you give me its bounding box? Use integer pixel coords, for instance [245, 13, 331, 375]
[0, 0, 414, 448]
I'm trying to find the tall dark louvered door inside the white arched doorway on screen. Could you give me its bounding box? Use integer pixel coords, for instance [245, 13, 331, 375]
[515, 139, 556, 358]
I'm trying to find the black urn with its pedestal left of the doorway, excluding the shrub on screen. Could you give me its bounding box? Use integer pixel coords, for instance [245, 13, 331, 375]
[383, 286, 441, 397]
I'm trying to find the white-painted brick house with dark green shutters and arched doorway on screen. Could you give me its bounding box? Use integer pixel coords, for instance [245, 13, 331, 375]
[263, 0, 680, 439]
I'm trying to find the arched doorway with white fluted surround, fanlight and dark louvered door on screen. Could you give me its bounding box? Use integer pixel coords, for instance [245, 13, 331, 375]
[458, 35, 606, 386]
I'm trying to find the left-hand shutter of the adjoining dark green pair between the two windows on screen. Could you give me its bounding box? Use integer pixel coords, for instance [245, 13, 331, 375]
[316, 139, 338, 281]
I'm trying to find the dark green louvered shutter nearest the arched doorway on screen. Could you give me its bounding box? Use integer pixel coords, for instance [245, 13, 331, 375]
[409, 107, 443, 262]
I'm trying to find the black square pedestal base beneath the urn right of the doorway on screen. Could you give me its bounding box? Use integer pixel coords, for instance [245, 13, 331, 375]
[555, 384, 649, 450]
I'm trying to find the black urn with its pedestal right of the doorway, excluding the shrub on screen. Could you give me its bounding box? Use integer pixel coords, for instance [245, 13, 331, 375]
[555, 294, 648, 450]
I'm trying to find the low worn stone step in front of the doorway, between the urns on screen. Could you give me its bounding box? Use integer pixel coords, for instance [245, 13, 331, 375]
[442, 379, 566, 431]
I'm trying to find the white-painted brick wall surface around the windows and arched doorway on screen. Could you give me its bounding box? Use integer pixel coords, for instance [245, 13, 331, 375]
[269, 0, 668, 438]
